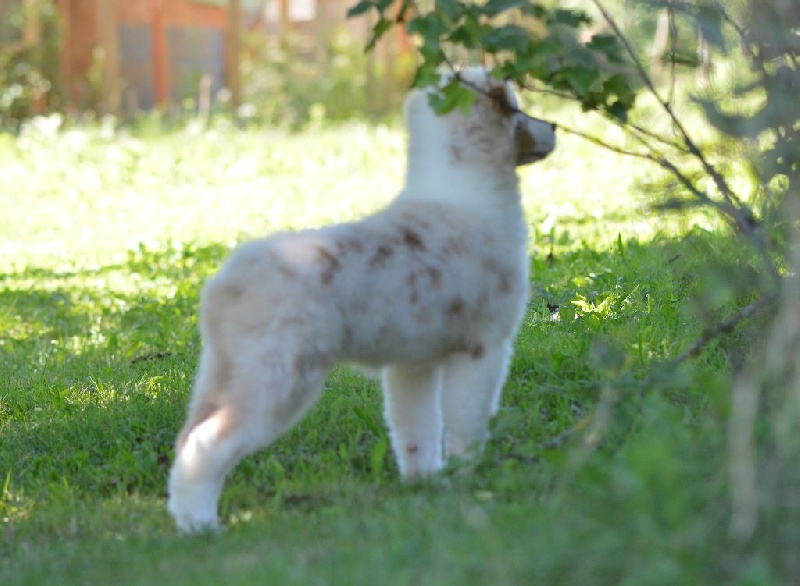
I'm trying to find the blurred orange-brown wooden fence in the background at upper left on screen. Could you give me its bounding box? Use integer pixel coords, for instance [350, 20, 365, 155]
[0, 0, 408, 113]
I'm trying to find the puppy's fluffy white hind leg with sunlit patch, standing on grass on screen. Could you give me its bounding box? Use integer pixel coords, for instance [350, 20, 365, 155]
[167, 344, 328, 532]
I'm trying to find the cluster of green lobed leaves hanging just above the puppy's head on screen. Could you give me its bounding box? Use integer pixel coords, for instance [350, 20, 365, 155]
[348, 0, 635, 120]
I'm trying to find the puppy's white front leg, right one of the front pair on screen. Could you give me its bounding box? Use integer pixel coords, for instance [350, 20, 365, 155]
[442, 341, 512, 456]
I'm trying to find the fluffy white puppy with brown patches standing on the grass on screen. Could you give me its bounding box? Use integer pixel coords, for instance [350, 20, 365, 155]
[168, 69, 555, 531]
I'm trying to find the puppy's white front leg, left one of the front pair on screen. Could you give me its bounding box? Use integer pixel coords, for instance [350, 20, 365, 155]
[383, 365, 442, 479]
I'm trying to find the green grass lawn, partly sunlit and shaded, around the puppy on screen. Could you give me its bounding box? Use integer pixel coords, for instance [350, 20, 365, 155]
[0, 121, 775, 586]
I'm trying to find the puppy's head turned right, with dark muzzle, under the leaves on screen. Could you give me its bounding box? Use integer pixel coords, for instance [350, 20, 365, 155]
[406, 68, 556, 168]
